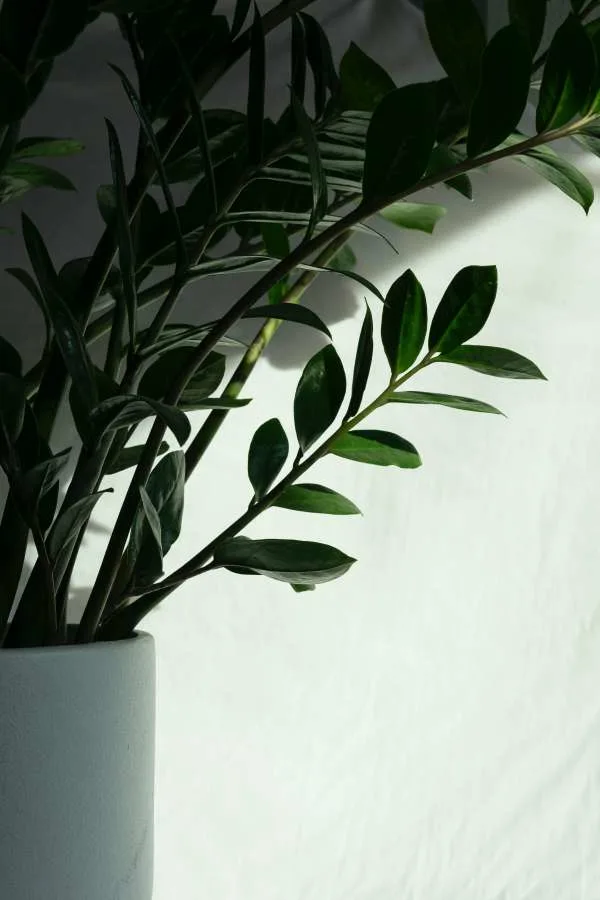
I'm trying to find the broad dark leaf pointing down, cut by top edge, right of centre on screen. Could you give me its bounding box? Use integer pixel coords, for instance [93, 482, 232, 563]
[425, 0, 486, 109]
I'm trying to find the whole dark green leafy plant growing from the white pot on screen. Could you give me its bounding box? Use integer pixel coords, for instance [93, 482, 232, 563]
[0, 0, 600, 647]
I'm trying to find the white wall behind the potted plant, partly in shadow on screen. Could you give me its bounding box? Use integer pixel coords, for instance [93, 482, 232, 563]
[3, 0, 600, 900]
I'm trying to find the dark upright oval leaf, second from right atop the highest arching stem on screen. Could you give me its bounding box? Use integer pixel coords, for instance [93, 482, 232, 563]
[467, 25, 531, 156]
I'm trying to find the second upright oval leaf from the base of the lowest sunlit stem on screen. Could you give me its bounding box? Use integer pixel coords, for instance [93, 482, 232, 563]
[294, 344, 346, 453]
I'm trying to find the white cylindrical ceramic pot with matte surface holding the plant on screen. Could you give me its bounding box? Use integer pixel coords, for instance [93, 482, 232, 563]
[0, 632, 155, 900]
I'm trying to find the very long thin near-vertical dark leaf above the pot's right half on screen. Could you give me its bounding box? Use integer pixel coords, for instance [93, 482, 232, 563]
[106, 119, 138, 353]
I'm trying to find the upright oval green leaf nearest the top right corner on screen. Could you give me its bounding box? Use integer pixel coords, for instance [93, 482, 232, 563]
[536, 15, 596, 132]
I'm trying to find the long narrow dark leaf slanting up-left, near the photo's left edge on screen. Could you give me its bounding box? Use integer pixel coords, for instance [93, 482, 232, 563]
[22, 213, 97, 408]
